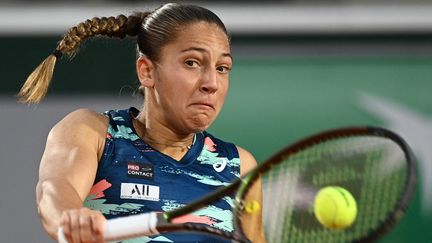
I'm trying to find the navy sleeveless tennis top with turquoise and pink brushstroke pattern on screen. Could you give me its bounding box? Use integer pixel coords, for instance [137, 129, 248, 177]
[84, 107, 240, 243]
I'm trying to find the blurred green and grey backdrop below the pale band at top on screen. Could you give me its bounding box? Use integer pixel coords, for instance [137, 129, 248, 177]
[0, 1, 432, 243]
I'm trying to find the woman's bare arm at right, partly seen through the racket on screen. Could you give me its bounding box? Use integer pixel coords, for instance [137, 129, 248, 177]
[237, 147, 266, 243]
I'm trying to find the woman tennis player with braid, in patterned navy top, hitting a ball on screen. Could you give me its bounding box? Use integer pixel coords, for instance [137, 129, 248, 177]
[24, 4, 261, 243]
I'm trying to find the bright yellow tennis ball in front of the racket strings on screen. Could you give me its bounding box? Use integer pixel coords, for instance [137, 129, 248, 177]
[314, 186, 357, 229]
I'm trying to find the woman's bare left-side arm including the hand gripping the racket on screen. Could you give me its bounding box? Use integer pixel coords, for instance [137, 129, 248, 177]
[36, 110, 107, 242]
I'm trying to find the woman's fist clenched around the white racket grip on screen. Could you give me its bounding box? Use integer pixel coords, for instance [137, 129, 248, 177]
[59, 207, 106, 243]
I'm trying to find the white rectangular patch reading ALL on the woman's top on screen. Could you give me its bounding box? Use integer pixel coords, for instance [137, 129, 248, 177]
[120, 183, 159, 201]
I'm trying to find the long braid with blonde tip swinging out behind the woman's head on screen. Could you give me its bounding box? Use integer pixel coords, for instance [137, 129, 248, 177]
[18, 13, 149, 103]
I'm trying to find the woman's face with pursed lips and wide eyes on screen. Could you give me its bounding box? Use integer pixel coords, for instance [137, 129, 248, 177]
[140, 22, 233, 133]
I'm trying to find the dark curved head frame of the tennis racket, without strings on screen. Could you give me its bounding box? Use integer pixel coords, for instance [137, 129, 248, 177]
[233, 126, 417, 242]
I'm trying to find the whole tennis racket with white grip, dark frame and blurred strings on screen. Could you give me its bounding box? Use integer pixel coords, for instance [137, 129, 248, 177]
[59, 127, 416, 243]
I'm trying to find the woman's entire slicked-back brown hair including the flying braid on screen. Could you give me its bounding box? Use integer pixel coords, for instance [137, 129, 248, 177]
[18, 3, 228, 103]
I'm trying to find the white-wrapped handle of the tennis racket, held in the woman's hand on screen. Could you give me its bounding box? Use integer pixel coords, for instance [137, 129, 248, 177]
[57, 212, 159, 243]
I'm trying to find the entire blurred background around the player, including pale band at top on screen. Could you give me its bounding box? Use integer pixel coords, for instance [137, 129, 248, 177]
[0, 0, 432, 242]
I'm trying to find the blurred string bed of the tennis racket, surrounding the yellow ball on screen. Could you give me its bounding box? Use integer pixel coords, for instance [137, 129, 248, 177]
[253, 137, 407, 243]
